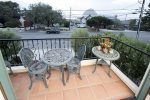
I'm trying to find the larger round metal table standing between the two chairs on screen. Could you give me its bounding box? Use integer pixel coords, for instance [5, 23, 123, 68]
[42, 48, 73, 85]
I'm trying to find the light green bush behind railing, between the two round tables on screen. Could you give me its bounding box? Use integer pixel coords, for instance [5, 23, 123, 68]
[71, 29, 99, 58]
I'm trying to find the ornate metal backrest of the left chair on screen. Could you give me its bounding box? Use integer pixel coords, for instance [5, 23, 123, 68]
[19, 48, 34, 67]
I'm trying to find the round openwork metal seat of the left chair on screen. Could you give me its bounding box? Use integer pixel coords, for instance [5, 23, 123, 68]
[29, 62, 47, 74]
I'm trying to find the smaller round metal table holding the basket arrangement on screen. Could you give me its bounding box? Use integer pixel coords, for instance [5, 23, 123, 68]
[92, 46, 120, 76]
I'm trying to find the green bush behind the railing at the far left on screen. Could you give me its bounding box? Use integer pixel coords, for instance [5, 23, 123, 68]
[0, 31, 21, 63]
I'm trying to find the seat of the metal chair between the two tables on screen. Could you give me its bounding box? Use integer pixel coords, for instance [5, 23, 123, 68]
[67, 58, 80, 69]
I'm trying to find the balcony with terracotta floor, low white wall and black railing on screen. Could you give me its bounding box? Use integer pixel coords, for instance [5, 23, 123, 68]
[0, 37, 150, 100]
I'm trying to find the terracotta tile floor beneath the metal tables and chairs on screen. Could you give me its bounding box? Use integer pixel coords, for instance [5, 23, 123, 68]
[10, 65, 134, 100]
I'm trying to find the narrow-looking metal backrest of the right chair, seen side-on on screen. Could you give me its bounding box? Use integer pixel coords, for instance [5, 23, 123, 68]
[77, 44, 86, 61]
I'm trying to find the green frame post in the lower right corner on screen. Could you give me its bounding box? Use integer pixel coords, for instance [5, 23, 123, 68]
[136, 64, 150, 100]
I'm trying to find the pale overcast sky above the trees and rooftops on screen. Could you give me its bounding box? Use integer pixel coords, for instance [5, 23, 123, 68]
[2, 0, 150, 20]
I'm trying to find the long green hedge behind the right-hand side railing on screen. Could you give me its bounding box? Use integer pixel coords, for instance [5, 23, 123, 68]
[99, 33, 150, 85]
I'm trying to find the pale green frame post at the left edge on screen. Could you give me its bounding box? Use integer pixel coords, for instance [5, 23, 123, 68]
[0, 51, 16, 100]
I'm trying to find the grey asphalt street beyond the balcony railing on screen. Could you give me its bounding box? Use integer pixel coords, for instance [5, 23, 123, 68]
[17, 29, 150, 44]
